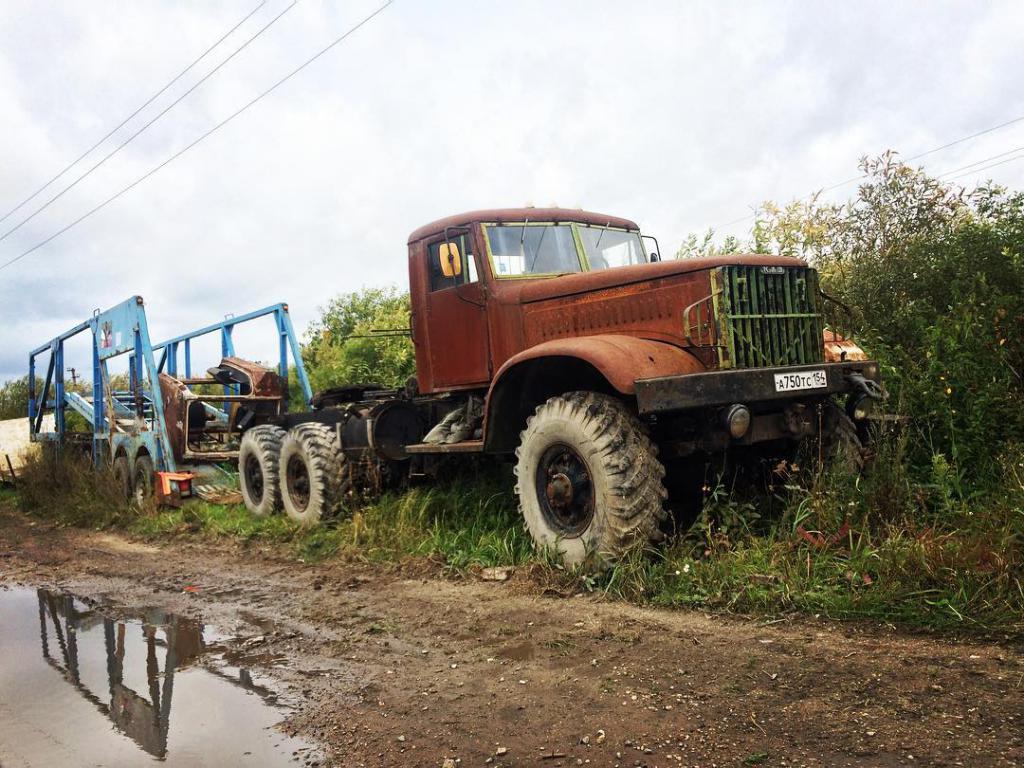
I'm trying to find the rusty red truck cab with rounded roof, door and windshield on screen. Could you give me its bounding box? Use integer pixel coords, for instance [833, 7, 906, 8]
[409, 208, 656, 392]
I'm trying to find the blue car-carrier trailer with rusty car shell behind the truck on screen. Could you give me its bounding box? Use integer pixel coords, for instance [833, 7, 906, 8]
[29, 296, 312, 500]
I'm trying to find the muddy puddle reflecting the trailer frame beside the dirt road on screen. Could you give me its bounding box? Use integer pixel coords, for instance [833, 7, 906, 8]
[0, 588, 316, 768]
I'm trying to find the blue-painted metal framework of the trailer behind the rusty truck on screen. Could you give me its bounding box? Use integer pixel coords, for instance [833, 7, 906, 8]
[29, 296, 312, 472]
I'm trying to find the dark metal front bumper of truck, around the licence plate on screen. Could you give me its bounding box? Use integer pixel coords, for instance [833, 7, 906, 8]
[636, 360, 879, 415]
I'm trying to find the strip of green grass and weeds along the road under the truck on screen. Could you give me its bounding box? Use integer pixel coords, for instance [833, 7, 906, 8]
[8, 442, 1024, 637]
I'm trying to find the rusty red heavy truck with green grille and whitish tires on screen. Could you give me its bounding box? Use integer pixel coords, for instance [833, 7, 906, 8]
[239, 208, 881, 563]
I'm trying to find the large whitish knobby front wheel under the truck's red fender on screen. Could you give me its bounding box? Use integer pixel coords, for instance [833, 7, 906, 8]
[515, 392, 668, 567]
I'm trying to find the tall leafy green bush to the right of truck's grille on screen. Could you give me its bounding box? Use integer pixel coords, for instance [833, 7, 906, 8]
[704, 154, 1024, 496]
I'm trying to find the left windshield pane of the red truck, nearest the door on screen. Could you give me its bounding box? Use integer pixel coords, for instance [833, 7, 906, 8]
[487, 224, 580, 278]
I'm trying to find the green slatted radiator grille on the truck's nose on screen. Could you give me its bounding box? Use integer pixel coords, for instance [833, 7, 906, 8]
[714, 266, 824, 368]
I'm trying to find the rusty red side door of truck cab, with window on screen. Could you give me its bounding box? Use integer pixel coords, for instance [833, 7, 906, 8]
[426, 230, 490, 388]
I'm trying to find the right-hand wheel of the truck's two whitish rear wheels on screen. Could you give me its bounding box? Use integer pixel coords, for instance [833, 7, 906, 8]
[278, 423, 348, 525]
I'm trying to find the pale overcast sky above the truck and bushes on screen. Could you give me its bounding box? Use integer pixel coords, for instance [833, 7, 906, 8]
[0, 0, 1024, 381]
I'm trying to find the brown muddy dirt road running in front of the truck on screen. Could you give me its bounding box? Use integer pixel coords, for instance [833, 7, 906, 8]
[0, 511, 1024, 767]
